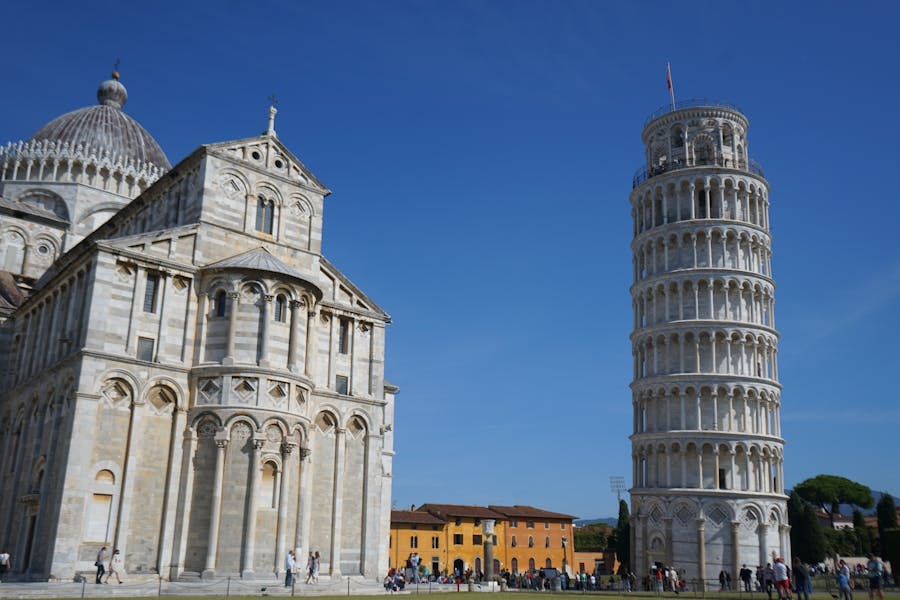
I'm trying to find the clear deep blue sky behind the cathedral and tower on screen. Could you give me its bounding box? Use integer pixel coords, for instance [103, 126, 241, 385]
[0, 0, 900, 517]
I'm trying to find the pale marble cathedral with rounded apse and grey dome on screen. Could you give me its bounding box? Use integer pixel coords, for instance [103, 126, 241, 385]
[0, 74, 397, 580]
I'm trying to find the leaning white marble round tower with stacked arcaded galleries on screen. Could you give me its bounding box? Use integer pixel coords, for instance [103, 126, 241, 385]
[630, 101, 790, 583]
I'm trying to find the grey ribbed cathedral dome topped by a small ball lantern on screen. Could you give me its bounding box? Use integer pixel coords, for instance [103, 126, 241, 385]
[28, 73, 171, 172]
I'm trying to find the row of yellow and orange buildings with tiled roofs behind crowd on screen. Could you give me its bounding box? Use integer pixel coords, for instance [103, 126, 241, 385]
[390, 504, 575, 574]
